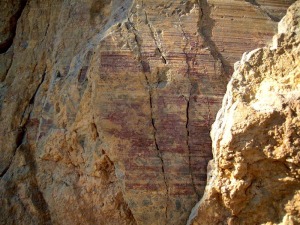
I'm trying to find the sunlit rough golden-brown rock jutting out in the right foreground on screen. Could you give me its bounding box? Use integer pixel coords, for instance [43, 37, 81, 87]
[188, 1, 300, 225]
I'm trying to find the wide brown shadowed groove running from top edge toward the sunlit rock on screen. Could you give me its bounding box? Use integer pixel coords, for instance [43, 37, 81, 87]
[198, 0, 233, 76]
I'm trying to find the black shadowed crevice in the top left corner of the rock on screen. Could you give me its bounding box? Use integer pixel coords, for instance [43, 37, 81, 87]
[0, 0, 27, 54]
